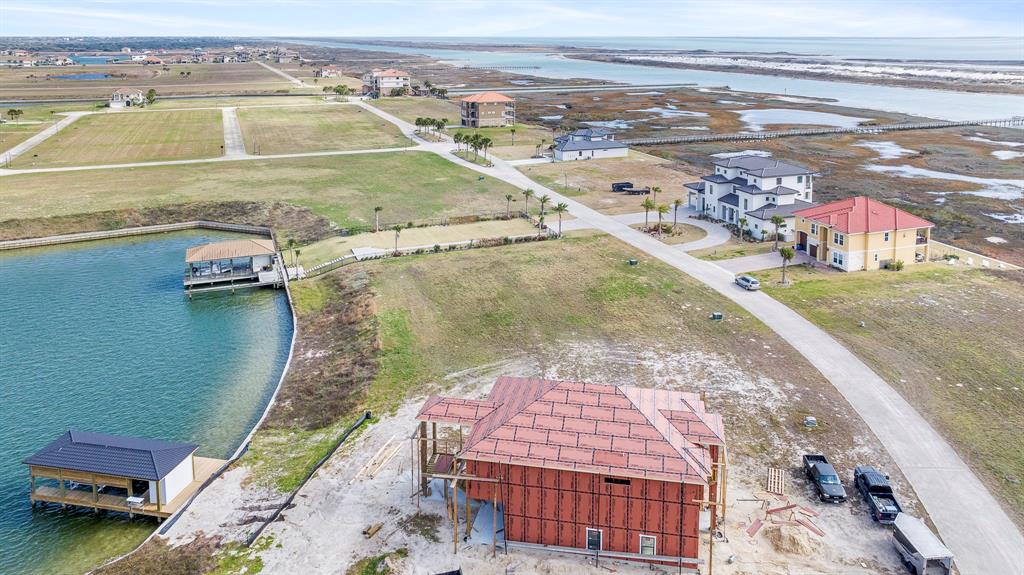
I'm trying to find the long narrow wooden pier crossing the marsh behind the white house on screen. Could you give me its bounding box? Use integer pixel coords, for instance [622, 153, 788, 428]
[618, 116, 1024, 145]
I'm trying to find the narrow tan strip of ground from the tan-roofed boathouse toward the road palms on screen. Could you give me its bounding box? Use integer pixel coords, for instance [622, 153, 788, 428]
[301, 218, 537, 269]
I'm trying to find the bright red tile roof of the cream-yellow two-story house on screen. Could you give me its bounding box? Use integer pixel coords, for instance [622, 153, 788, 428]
[793, 195, 935, 233]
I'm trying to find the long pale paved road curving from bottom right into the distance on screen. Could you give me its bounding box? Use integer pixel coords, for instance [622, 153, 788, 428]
[361, 98, 1024, 575]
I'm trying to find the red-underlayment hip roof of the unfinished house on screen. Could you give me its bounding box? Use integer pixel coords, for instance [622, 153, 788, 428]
[417, 378, 725, 484]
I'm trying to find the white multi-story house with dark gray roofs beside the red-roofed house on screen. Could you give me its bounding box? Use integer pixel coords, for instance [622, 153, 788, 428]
[685, 156, 816, 241]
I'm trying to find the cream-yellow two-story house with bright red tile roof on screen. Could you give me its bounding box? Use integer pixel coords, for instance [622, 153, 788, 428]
[794, 195, 935, 271]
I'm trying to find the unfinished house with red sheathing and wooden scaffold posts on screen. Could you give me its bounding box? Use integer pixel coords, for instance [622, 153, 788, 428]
[412, 378, 726, 571]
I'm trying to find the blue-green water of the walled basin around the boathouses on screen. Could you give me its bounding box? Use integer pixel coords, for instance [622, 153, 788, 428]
[0, 231, 293, 575]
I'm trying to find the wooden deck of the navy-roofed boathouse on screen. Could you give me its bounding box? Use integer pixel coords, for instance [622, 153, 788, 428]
[30, 456, 227, 519]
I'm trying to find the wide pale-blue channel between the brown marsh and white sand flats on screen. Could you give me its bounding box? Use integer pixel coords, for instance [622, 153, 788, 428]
[295, 39, 1024, 120]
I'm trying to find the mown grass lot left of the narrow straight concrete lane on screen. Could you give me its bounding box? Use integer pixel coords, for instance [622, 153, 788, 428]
[12, 109, 224, 168]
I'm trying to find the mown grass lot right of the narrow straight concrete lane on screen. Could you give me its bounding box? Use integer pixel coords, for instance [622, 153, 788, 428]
[238, 104, 412, 153]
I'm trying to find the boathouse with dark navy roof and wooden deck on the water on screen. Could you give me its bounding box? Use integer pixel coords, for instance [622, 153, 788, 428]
[23, 430, 227, 520]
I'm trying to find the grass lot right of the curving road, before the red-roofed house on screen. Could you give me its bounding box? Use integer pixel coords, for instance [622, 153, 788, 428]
[755, 264, 1024, 524]
